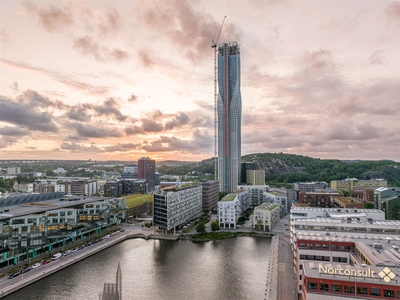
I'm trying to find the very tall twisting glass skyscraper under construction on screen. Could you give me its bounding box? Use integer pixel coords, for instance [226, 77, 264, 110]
[218, 42, 242, 192]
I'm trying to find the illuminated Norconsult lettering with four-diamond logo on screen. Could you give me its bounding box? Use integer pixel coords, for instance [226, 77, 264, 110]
[318, 265, 396, 282]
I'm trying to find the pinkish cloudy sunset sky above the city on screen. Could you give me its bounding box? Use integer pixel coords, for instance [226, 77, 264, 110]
[0, 0, 400, 161]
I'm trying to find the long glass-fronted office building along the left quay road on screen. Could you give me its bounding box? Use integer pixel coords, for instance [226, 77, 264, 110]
[0, 197, 126, 268]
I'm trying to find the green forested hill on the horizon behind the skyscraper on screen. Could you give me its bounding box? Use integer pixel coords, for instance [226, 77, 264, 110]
[157, 153, 400, 186]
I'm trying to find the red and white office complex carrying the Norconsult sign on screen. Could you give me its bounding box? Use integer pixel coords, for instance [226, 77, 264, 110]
[290, 207, 400, 300]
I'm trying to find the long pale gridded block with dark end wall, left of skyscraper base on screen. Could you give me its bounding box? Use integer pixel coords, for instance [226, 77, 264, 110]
[153, 183, 203, 232]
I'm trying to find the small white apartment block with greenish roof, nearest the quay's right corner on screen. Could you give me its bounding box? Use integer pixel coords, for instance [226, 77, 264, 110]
[252, 203, 281, 232]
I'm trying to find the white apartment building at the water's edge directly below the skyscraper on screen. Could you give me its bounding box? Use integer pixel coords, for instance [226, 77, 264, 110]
[218, 191, 251, 229]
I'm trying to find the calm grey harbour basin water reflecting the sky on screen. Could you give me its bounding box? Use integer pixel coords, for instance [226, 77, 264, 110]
[4, 237, 271, 300]
